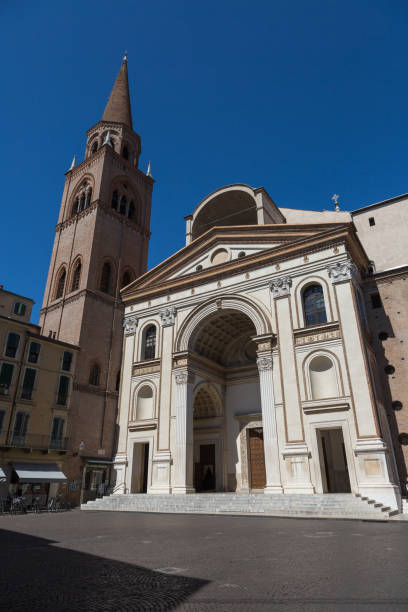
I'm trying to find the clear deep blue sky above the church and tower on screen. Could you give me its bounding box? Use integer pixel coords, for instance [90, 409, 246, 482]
[0, 0, 408, 321]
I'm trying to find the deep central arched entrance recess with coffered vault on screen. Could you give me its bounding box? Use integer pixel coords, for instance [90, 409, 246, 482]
[188, 309, 263, 492]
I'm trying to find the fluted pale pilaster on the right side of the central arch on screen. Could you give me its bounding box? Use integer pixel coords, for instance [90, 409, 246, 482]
[256, 351, 283, 493]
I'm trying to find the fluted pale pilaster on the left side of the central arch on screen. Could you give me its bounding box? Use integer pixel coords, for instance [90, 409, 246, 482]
[173, 370, 195, 493]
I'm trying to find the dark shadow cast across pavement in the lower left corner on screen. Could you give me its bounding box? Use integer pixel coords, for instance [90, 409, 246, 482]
[0, 530, 207, 612]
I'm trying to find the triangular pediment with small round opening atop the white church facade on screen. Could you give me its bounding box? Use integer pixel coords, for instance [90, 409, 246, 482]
[121, 223, 355, 302]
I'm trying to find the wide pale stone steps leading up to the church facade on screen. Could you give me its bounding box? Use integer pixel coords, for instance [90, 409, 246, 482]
[81, 493, 398, 520]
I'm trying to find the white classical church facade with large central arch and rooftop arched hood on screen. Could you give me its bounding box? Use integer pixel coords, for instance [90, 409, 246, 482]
[114, 185, 400, 508]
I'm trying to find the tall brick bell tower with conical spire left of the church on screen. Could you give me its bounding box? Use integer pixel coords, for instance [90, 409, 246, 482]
[40, 55, 154, 502]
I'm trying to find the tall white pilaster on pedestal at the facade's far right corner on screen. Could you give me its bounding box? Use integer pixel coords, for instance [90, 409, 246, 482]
[327, 259, 401, 508]
